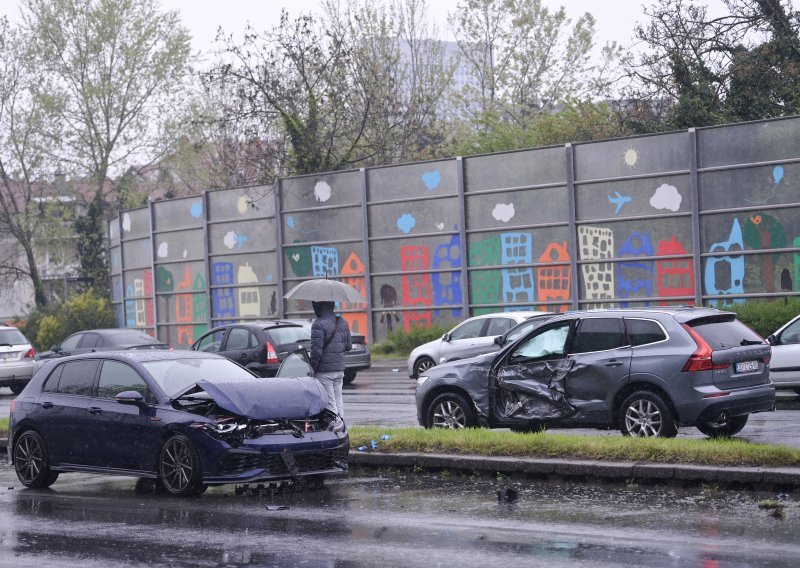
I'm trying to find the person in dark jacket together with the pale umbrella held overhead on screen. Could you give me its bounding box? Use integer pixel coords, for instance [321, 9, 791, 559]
[283, 276, 365, 418]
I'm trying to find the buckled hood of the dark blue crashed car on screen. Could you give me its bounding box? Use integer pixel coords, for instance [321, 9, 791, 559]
[197, 377, 328, 420]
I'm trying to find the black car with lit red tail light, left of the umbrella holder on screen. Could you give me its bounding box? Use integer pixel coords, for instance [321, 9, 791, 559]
[190, 320, 311, 377]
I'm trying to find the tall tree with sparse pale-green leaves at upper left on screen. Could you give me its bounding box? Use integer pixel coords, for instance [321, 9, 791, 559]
[22, 0, 190, 290]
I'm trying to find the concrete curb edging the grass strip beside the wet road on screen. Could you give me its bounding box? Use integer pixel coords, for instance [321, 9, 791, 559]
[348, 451, 800, 491]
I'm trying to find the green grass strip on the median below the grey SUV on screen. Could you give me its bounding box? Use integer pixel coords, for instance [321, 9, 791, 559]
[350, 426, 800, 467]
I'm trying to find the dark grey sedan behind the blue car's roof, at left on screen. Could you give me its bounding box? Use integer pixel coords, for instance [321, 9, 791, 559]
[36, 328, 170, 360]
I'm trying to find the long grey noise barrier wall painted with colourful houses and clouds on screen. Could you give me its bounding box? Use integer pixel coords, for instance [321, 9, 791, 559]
[109, 117, 800, 347]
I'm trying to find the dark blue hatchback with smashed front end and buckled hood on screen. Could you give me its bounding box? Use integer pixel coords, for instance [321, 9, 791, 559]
[8, 351, 350, 496]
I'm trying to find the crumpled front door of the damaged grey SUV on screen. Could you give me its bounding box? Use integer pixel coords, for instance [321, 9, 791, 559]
[495, 359, 576, 420]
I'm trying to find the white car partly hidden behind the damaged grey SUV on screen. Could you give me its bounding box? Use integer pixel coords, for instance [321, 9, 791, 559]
[408, 311, 551, 379]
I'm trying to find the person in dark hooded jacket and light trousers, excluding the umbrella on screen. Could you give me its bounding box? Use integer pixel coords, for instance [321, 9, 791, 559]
[310, 301, 353, 419]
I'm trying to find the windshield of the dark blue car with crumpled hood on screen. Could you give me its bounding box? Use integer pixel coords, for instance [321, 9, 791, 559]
[142, 359, 253, 398]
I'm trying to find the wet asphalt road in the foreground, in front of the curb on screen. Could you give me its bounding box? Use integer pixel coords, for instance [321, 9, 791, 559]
[0, 463, 800, 568]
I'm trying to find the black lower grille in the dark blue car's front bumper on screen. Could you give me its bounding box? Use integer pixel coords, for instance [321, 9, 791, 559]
[220, 448, 347, 477]
